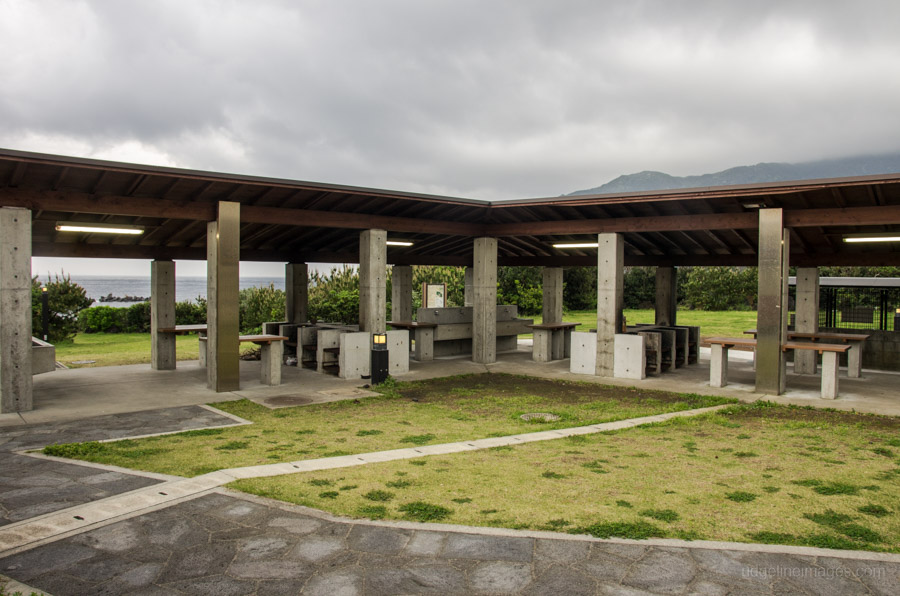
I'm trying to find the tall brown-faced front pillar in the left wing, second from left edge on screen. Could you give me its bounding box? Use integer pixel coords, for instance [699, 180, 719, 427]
[206, 201, 241, 392]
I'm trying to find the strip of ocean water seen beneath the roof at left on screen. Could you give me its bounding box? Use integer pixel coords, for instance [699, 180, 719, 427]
[32, 275, 284, 306]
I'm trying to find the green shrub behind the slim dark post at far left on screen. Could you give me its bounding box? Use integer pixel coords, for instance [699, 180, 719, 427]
[31, 274, 94, 343]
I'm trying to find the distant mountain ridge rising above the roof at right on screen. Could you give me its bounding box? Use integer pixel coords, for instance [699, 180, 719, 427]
[566, 153, 900, 196]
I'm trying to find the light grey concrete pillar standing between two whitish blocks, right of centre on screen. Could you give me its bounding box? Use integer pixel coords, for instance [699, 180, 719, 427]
[597, 234, 625, 377]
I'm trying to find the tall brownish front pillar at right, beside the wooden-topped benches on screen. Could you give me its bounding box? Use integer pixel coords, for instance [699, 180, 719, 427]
[756, 209, 790, 395]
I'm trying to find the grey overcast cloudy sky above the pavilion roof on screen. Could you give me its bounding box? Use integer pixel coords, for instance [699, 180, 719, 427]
[0, 0, 900, 278]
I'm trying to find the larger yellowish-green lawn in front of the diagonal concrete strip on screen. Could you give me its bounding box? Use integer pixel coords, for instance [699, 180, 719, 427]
[232, 402, 900, 552]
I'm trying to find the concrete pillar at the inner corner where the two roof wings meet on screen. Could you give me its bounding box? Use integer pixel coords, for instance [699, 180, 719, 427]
[472, 238, 497, 364]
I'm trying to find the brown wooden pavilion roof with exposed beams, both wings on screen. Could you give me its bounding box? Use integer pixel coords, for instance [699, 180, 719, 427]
[0, 149, 900, 266]
